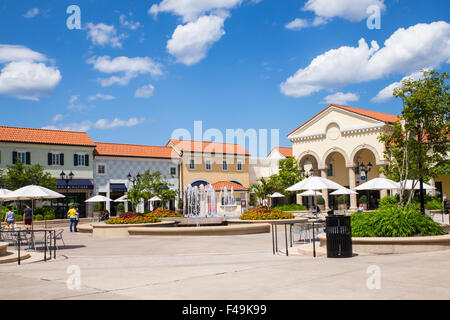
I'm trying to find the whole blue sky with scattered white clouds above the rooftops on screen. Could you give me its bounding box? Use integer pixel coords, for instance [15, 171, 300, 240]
[0, 0, 450, 153]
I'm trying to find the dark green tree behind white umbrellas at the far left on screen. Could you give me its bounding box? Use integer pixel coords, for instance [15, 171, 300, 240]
[1, 161, 56, 190]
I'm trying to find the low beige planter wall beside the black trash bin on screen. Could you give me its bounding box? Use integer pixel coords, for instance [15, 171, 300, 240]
[318, 234, 450, 254]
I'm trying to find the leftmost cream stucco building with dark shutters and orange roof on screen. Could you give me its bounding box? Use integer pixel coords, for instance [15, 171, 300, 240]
[0, 126, 95, 217]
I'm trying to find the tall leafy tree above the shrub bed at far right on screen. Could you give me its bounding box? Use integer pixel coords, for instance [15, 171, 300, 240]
[379, 71, 450, 205]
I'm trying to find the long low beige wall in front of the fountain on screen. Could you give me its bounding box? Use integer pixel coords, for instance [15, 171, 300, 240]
[128, 224, 270, 237]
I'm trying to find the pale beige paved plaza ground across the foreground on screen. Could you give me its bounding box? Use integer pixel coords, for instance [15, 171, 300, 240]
[0, 229, 450, 299]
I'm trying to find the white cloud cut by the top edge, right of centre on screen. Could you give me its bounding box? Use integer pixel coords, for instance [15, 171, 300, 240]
[303, 0, 386, 22]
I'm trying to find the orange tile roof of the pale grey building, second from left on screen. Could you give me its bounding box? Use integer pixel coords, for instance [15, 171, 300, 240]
[94, 142, 179, 159]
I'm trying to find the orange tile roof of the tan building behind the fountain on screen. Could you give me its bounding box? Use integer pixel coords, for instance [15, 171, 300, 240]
[167, 139, 250, 155]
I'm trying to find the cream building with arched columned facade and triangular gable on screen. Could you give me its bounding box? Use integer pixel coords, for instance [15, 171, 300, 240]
[288, 104, 404, 209]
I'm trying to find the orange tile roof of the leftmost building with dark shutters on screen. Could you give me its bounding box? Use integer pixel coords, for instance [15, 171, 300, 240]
[0, 126, 95, 147]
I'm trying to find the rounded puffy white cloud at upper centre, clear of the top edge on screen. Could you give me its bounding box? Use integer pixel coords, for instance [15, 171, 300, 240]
[167, 15, 225, 66]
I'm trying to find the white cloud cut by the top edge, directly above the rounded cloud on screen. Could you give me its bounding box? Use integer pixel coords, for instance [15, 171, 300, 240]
[148, 0, 242, 22]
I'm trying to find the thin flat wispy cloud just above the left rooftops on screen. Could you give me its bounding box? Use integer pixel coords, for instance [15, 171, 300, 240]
[43, 117, 145, 131]
